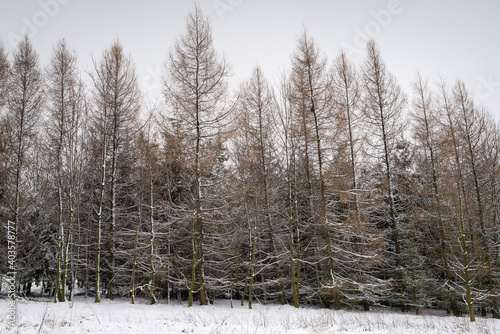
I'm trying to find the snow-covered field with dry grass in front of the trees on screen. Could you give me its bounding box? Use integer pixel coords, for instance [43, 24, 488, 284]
[0, 298, 500, 334]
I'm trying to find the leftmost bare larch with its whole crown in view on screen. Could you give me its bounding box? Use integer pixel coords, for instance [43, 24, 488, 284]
[6, 36, 44, 290]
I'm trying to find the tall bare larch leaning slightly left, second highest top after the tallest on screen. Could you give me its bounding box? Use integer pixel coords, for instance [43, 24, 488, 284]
[291, 32, 340, 309]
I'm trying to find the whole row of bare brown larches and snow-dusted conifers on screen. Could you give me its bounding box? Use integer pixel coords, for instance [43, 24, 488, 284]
[0, 7, 500, 321]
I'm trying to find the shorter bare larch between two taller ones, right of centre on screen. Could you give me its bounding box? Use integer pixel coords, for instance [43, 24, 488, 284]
[329, 50, 386, 310]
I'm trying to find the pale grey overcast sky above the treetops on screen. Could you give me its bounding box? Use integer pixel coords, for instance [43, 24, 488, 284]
[0, 0, 500, 120]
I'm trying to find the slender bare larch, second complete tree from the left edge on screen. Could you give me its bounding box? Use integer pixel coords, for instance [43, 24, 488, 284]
[46, 40, 84, 301]
